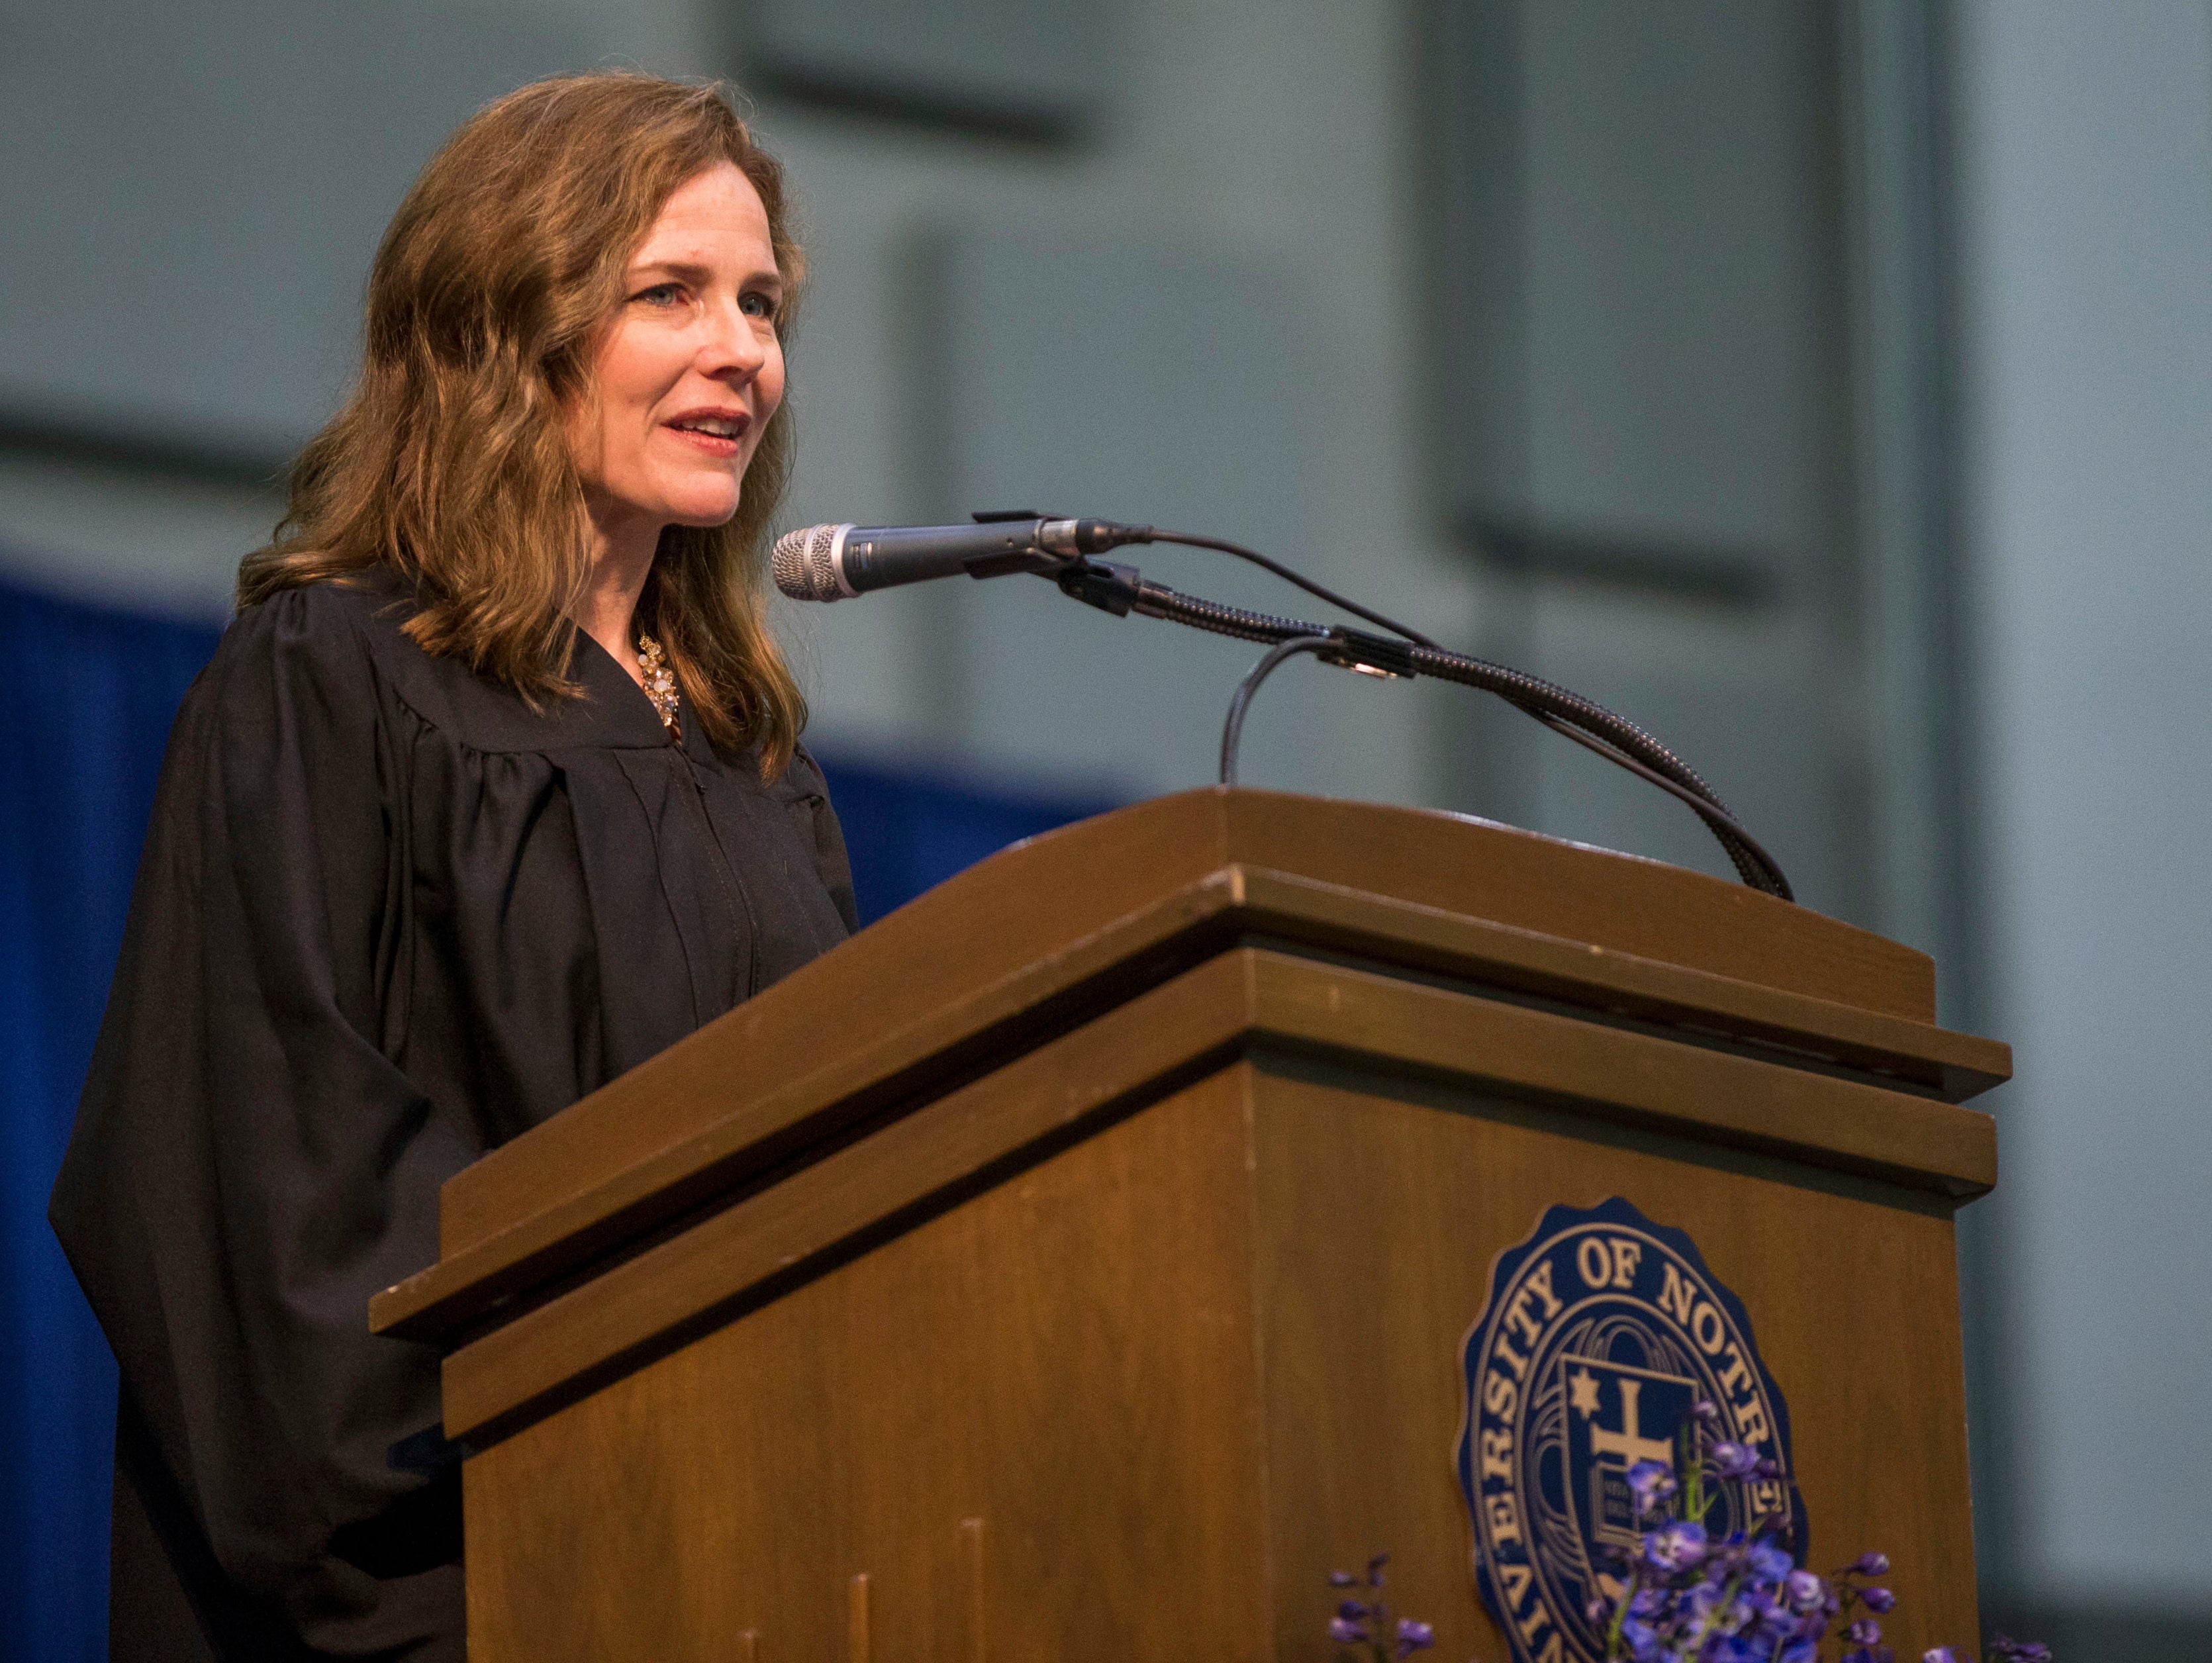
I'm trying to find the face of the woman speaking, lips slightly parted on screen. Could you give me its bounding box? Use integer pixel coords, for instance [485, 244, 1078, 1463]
[569, 162, 783, 551]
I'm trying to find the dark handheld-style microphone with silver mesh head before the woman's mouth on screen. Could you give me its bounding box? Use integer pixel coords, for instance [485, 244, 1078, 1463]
[770, 513, 1153, 602]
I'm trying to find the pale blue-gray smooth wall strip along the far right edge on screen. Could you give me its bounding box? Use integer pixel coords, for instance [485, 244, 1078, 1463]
[1960, 0, 2212, 1619]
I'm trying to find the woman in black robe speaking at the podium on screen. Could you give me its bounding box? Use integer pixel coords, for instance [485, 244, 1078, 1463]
[53, 75, 854, 1658]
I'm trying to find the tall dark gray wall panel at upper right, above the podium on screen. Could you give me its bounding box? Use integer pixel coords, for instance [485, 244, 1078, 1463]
[1442, 0, 1843, 591]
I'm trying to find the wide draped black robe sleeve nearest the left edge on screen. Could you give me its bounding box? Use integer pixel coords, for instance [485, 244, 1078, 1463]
[53, 589, 473, 1658]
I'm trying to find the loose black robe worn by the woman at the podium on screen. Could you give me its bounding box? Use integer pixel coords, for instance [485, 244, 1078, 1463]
[53, 584, 854, 1658]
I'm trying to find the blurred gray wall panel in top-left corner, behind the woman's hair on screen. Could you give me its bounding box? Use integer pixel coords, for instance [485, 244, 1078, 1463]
[0, 0, 641, 457]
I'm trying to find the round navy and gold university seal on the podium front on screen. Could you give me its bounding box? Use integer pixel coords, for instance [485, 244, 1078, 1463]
[1458, 1196, 1805, 1663]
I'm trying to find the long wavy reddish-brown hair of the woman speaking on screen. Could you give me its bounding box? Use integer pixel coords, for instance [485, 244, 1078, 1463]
[239, 73, 807, 779]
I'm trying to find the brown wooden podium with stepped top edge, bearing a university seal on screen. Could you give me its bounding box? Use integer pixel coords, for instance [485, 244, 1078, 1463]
[371, 790, 2011, 1663]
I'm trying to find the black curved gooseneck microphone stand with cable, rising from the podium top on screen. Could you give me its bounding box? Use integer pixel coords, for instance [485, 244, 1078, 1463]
[1035, 553, 1796, 900]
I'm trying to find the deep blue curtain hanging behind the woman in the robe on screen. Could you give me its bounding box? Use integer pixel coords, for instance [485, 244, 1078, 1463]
[0, 584, 1113, 1663]
